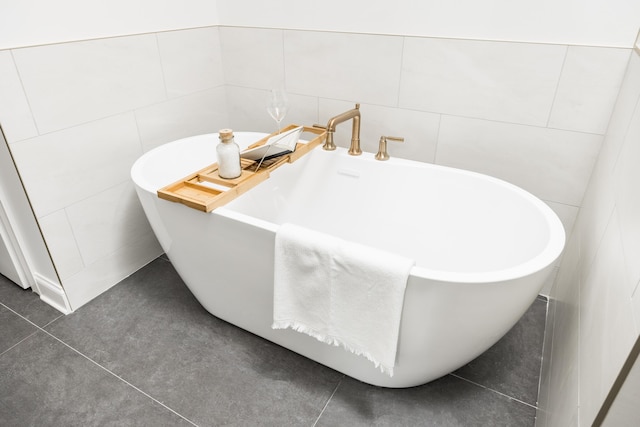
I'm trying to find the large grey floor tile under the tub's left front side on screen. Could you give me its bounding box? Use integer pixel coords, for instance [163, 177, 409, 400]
[47, 258, 342, 426]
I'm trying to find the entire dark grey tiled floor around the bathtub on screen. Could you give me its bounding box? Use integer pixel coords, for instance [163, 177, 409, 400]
[0, 257, 546, 427]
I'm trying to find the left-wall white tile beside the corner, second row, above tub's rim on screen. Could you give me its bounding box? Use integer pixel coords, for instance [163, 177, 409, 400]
[135, 87, 229, 152]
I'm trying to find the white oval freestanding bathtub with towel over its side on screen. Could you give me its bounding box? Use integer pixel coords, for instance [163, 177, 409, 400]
[131, 132, 564, 387]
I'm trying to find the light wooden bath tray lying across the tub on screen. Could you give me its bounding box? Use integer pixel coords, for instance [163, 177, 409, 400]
[158, 125, 327, 212]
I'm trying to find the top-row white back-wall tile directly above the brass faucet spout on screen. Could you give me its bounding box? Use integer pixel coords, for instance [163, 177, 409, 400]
[284, 31, 403, 106]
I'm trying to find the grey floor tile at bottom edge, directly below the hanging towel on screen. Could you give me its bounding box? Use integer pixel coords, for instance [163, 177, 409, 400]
[317, 375, 535, 427]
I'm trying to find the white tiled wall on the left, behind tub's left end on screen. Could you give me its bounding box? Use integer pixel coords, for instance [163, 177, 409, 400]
[0, 27, 228, 309]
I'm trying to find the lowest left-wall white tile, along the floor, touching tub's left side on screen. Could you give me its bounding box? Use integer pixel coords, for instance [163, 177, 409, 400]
[64, 234, 162, 310]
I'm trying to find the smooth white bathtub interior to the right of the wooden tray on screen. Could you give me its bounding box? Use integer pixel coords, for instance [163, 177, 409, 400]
[225, 150, 552, 280]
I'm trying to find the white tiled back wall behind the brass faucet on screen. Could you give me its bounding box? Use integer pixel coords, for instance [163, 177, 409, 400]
[220, 27, 630, 294]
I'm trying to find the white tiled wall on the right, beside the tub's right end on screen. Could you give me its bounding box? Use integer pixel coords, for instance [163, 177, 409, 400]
[537, 47, 640, 426]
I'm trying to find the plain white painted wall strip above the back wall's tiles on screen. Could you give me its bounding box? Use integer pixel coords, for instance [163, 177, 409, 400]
[217, 0, 640, 48]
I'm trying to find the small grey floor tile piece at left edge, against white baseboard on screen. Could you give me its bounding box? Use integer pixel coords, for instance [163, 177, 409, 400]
[0, 275, 63, 327]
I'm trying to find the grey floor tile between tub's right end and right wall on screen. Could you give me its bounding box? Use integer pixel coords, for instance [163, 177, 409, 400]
[455, 298, 547, 406]
